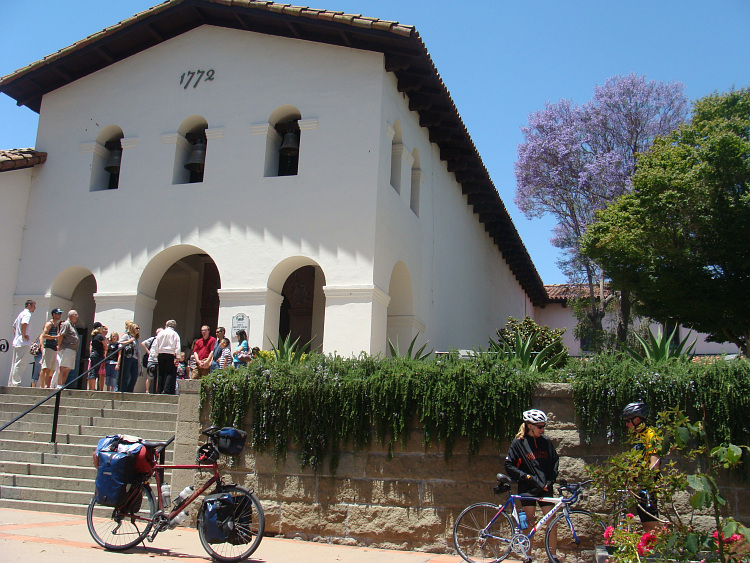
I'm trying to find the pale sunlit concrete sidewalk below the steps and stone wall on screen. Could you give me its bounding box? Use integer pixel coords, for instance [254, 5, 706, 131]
[0, 508, 462, 563]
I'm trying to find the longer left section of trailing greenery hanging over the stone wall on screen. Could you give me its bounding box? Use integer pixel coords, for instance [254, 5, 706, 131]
[201, 354, 539, 472]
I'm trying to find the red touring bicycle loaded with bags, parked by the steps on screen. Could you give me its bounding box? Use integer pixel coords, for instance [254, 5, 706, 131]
[86, 426, 265, 563]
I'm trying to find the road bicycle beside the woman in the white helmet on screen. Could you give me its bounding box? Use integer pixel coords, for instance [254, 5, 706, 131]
[453, 473, 604, 563]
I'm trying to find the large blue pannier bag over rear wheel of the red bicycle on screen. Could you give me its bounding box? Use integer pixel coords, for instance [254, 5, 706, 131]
[95, 435, 143, 508]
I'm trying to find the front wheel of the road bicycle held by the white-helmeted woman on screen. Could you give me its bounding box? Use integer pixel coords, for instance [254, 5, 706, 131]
[544, 509, 604, 563]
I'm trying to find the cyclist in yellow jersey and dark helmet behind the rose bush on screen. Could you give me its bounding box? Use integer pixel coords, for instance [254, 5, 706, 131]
[621, 402, 661, 532]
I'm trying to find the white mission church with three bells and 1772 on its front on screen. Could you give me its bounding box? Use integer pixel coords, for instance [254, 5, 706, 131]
[0, 0, 740, 390]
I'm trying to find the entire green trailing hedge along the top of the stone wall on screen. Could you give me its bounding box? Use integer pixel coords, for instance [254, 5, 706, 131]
[201, 354, 750, 472]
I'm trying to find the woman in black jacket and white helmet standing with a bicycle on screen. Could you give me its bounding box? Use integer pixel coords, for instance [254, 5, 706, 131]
[505, 409, 559, 563]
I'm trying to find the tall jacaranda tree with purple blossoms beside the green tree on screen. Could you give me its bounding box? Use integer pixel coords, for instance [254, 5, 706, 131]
[515, 74, 688, 348]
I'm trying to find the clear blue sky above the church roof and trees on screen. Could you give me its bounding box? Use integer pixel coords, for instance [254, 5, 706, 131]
[0, 0, 750, 283]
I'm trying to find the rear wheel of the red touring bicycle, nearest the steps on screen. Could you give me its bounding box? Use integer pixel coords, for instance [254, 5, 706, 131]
[86, 483, 156, 551]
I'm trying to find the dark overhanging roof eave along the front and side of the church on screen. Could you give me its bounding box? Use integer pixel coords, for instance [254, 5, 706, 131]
[0, 0, 548, 305]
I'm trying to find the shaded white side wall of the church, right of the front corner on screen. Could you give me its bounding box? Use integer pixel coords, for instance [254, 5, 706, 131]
[375, 70, 532, 350]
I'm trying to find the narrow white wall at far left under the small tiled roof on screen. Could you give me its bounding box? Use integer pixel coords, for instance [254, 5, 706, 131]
[0, 167, 35, 385]
